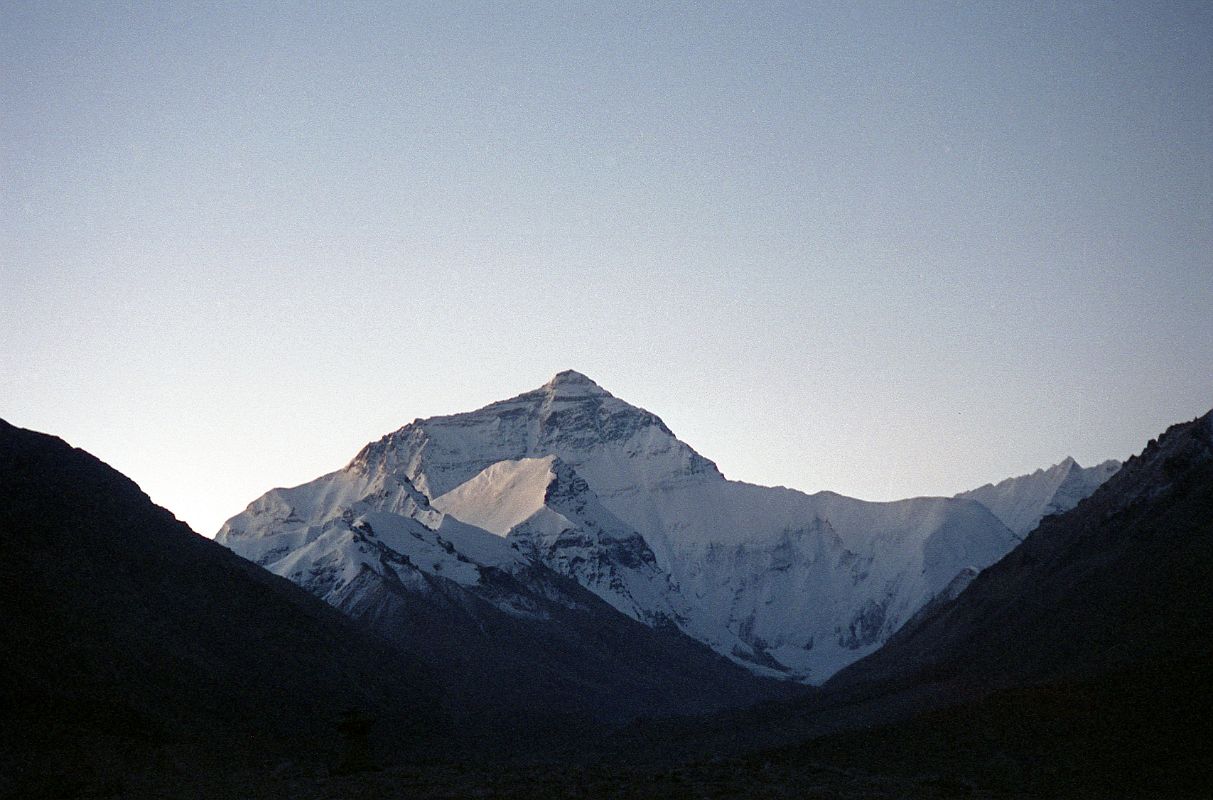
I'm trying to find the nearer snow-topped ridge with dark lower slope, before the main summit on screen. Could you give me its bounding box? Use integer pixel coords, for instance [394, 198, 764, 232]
[216, 436, 770, 728]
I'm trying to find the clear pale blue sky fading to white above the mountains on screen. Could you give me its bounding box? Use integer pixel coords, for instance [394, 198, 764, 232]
[0, 0, 1213, 535]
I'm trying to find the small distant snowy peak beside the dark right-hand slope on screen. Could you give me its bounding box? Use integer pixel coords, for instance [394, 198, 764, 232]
[957, 457, 1121, 537]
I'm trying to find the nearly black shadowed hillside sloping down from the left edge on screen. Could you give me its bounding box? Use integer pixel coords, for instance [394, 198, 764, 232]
[0, 421, 444, 796]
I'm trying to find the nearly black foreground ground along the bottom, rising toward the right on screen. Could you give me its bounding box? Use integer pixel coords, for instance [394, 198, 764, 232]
[47, 644, 1213, 800]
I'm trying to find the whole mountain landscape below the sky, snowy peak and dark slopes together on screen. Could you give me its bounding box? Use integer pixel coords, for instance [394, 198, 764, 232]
[7, 373, 1213, 799]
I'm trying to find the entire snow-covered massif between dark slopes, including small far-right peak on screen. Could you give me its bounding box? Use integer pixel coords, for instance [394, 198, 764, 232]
[216, 371, 1115, 682]
